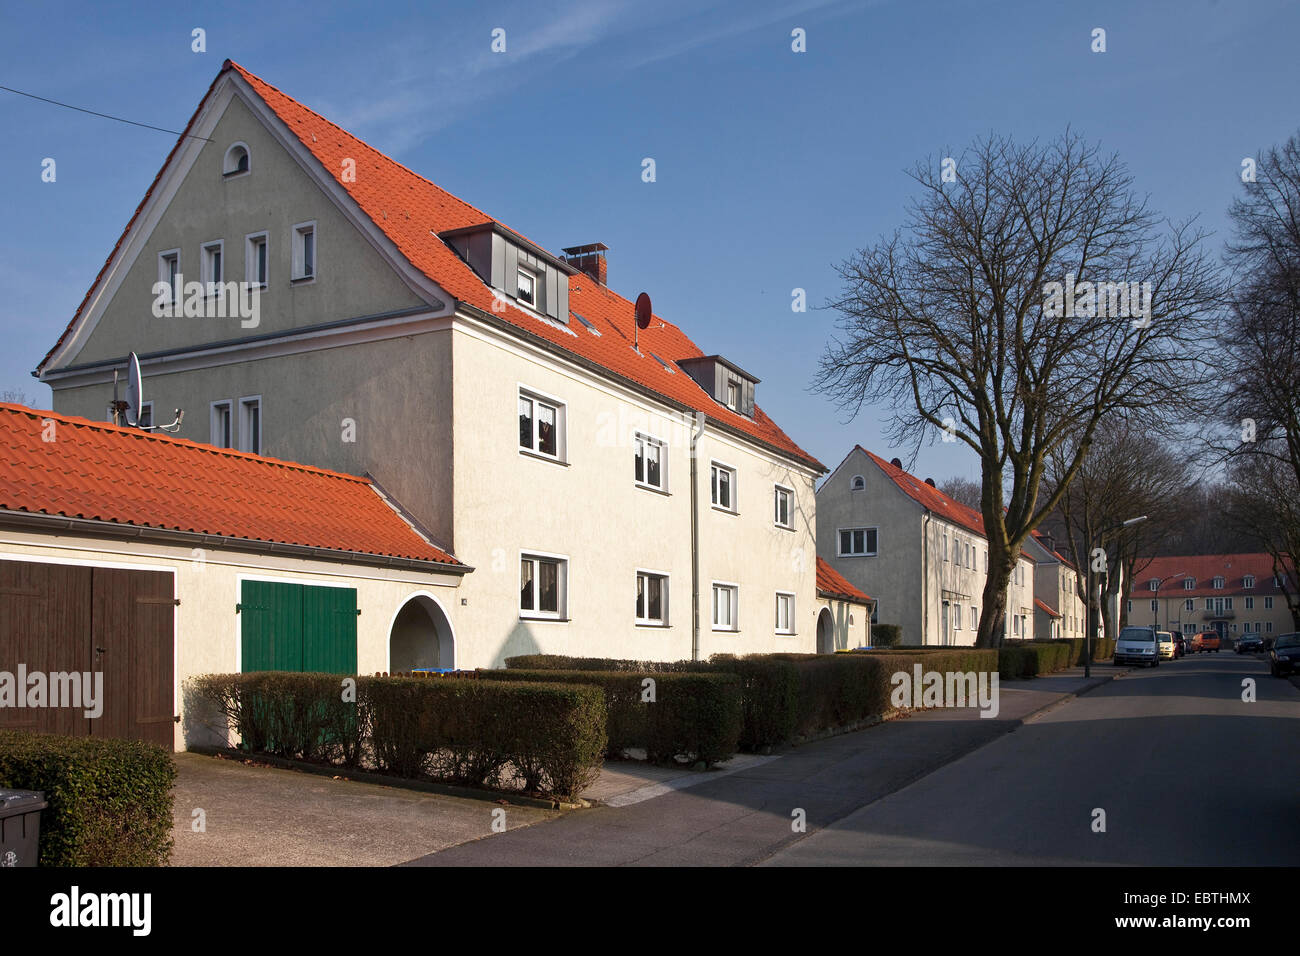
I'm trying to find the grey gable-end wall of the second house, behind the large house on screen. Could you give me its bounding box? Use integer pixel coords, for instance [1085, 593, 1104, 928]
[816, 449, 926, 644]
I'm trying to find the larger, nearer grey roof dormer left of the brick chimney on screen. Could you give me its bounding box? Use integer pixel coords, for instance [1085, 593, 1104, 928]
[438, 222, 577, 325]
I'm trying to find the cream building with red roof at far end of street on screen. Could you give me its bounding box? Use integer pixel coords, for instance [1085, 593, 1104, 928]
[1127, 554, 1296, 637]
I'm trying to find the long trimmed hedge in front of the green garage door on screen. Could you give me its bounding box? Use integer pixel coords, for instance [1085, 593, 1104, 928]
[186, 671, 606, 800]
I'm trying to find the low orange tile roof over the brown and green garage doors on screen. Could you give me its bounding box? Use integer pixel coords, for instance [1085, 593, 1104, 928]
[0, 403, 467, 571]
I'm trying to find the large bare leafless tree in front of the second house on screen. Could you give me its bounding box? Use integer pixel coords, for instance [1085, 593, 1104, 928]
[816, 131, 1218, 646]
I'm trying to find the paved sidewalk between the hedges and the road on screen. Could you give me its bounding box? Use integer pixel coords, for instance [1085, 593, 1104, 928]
[408, 665, 1125, 866]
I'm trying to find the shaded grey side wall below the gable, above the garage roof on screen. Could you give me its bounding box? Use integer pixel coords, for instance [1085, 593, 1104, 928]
[55, 329, 455, 548]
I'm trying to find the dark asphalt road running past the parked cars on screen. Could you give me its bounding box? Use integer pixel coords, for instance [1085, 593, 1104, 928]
[764, 652, 1300, 866]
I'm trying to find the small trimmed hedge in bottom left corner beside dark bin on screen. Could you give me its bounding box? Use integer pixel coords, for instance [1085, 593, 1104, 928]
[0, 731, 176, 866]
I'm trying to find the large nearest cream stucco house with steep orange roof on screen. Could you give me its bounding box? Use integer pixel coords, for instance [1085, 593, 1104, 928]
[36, 61, 826, 667]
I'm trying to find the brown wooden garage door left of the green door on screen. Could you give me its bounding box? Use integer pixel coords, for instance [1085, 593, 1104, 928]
[0, 561, 176, 750]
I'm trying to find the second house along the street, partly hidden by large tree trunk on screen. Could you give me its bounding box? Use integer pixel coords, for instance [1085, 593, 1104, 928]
[816, 445, 1036, 645]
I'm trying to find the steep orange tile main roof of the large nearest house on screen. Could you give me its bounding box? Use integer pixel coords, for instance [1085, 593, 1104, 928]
[40, 60, 826, 471]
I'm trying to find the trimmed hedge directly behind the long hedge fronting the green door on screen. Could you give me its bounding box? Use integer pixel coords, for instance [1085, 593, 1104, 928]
[478, 661, 741, 766]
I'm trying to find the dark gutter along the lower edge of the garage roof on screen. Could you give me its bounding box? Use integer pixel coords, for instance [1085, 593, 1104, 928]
[0, 509, 473, 575]
